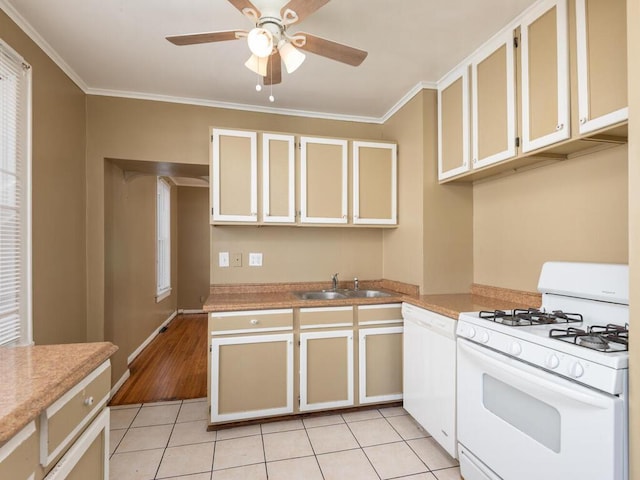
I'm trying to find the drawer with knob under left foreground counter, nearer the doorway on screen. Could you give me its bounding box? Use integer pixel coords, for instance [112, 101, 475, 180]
[40, 360, 111, 467]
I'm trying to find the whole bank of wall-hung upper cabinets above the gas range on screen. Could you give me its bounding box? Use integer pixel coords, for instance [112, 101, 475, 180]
[438, 0, 628, 182]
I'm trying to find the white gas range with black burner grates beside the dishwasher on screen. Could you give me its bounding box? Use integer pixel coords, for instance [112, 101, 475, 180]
[456, 262, 629, 480]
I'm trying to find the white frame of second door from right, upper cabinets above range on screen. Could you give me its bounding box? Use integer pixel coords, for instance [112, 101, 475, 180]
[520, 0, 571, 153]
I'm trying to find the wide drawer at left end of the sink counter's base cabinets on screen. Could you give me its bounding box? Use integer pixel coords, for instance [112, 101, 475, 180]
[209, 308, 293, 335]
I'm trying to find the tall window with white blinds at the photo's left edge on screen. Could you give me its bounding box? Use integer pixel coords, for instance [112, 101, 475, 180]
[0, 40, 33, 345]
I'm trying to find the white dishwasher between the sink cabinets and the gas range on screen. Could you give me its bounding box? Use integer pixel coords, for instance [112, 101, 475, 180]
[402, 303, 458, 458]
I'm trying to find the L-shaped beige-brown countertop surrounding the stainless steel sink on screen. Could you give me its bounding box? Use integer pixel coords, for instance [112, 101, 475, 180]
[203, 280, 540, 319]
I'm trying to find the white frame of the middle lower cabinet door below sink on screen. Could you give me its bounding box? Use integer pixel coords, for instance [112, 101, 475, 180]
[300, 330, 354, 412]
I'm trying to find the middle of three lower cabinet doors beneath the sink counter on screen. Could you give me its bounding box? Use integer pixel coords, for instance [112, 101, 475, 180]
[300, 330, 354, 411]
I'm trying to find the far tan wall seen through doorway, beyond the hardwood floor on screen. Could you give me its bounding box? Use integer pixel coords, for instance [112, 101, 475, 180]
[174, 187, 210, 310]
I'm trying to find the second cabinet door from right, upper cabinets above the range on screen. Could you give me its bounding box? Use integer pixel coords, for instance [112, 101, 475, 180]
[520, 0, 571, 152]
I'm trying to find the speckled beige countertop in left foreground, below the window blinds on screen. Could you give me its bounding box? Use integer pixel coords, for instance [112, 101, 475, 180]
[0, 342, 118, 445]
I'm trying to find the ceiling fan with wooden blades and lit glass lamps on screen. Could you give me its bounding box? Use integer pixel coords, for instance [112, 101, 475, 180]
[166, 0, 367, 85]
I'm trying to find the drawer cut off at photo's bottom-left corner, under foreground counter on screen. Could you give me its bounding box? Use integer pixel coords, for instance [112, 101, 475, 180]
[0, 422, 39, 480]
